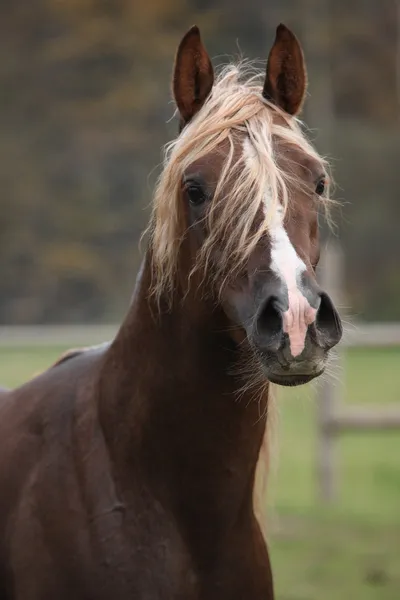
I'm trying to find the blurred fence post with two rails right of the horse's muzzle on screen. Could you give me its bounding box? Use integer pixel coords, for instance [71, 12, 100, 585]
[317, 245, 400, 503]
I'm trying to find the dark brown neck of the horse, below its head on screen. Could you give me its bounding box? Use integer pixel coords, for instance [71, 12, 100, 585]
[100, 252, 266, 540]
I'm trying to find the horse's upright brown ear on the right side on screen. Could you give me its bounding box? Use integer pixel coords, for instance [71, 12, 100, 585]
[263, 24, 307, 115]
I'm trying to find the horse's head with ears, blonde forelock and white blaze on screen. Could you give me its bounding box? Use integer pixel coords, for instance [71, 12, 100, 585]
[148, 25, 342, 385]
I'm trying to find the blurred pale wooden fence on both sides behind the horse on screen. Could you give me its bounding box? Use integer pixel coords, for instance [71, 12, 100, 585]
[0, 245, 400, 502]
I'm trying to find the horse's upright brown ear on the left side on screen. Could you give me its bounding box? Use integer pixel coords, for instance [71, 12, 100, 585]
[172, 25, 214, 124]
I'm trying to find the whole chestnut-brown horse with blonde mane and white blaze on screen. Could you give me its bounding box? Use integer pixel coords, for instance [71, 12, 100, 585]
[0, 24, 342, 600]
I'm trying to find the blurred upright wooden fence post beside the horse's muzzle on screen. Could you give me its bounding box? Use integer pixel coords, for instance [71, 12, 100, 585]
[317, 242, 343, 503]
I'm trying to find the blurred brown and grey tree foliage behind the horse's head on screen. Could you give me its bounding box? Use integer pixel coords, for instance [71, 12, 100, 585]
[0, 0, 400, 323]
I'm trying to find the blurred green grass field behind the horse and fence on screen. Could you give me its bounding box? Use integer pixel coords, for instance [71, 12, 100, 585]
[0, 347, 400, 600]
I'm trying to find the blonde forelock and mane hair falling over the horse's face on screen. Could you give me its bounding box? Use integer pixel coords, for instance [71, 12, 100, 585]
[149, 62, 328, 299]
